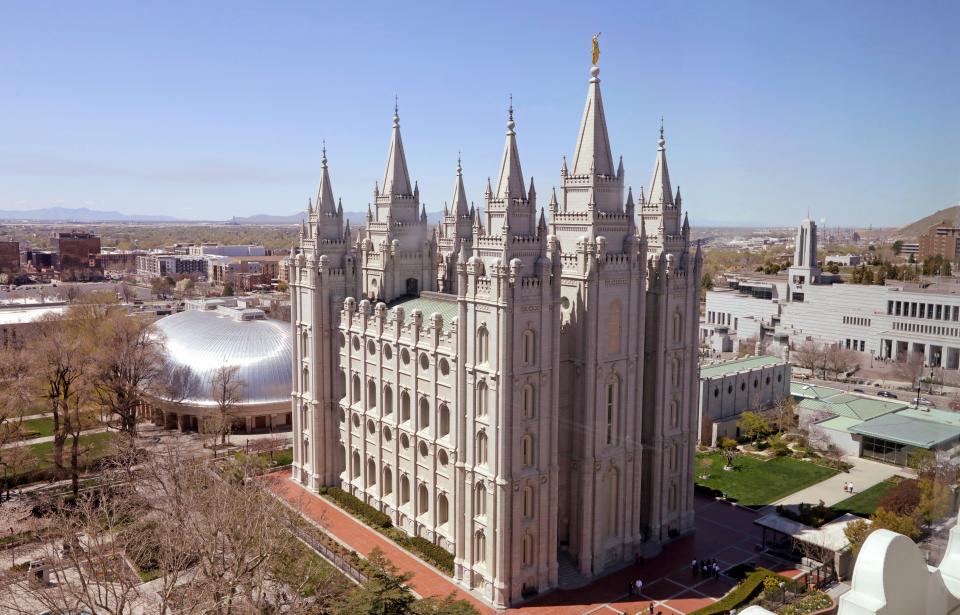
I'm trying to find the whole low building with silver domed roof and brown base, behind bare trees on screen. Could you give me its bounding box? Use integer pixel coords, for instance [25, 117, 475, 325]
[149, 303, 292, 433]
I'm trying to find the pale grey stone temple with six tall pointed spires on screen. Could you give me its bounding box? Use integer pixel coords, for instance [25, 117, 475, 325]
[289, 60, 702, 607]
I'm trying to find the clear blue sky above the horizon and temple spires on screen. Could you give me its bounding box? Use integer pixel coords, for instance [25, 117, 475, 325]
[0, 0, 960, 226]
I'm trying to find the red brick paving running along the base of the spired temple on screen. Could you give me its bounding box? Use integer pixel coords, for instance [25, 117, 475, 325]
[264, 473, 800, 615]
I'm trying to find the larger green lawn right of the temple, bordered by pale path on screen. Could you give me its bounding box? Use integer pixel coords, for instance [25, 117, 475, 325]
[697, 453, 837, 506]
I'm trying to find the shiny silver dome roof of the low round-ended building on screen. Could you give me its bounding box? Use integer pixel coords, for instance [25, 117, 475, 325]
[154, 310, 293, 406]
